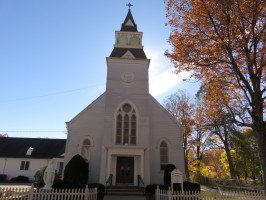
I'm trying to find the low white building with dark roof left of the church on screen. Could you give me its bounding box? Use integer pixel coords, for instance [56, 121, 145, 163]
[0, 137, 66, 180]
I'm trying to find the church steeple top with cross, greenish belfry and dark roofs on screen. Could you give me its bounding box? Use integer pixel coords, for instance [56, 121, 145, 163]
[110, 3, 147, 59]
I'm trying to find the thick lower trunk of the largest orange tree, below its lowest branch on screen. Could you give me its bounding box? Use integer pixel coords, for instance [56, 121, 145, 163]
[253, 125, 266, 191]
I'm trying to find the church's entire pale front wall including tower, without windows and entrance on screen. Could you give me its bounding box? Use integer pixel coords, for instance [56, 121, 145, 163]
[65, 58, 184, 184]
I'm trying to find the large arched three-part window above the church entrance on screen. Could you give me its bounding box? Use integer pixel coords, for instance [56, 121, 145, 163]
[115, 103, 137, 145]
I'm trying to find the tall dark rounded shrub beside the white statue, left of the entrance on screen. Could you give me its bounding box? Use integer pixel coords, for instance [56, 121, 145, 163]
[64, 154, 88, 188]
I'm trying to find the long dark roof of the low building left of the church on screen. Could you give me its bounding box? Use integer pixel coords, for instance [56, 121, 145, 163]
[0, 137, 66, 158]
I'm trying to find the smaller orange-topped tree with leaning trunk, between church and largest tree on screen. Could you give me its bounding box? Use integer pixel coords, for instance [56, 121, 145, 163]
[197, 80, 242, 178]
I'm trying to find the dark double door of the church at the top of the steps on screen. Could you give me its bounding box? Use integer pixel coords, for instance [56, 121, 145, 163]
[116, 157, 134, 184]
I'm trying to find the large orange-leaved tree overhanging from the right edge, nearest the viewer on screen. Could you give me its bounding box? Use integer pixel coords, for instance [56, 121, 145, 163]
[165, 0, 266, 189]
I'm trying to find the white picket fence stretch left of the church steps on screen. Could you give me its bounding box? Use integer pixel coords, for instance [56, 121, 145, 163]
[0, 187, 97, 200]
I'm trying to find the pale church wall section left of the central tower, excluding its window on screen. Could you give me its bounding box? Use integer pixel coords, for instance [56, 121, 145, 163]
[65, 94, 105, 183]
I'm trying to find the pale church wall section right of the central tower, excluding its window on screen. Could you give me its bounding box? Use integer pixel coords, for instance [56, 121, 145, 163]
[150, 97, 185, 184]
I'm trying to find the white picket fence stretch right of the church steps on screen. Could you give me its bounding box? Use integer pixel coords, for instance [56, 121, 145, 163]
[155, 188, 266, 200]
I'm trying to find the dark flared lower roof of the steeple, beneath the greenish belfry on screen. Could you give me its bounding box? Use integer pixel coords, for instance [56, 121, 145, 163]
[110, 47, 147, 59]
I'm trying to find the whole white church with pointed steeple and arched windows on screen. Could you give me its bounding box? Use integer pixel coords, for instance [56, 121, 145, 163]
[64, 9, 185, 185]
